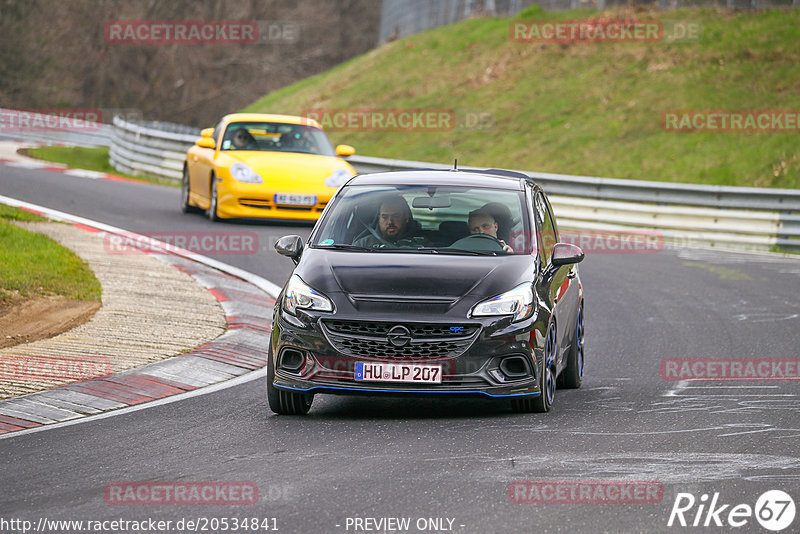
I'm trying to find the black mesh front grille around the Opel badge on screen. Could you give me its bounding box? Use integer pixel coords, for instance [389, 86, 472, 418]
[322, 319, 480, 359]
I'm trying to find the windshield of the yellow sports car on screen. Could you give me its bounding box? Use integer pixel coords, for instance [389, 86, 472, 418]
[220, 122, 335, 156]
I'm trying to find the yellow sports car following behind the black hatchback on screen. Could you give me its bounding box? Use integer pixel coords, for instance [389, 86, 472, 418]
[181, 113, 356, 221]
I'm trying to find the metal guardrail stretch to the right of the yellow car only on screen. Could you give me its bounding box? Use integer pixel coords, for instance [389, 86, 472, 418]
[347, 156, 800, 252]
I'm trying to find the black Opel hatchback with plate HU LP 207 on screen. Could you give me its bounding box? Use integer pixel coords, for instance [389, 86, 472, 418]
[267, 169, 584, 414]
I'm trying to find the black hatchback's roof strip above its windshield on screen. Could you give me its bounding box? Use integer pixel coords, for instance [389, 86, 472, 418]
[347, 169, 538, 191]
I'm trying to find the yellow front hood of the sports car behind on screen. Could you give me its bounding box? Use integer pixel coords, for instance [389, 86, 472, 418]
[226, 151, 355, 188]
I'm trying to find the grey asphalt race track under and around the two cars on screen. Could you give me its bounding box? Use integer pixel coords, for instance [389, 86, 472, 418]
[0, 166, 800, 533]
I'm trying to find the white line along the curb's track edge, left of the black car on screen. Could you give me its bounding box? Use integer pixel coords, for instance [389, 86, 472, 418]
[0, 195, 281, 298]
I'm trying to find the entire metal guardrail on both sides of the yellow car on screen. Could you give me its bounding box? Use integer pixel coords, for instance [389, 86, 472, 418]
[4, 110, 780, 252]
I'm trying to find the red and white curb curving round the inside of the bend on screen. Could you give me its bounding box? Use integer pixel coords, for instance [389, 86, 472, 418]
[0, 196, 280, 437]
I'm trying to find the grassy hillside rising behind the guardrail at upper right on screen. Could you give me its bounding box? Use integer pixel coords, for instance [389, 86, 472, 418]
[246, 7, 800, 188]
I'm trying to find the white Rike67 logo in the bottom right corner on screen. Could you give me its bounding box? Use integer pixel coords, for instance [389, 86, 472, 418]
[667, 490, 795, 532]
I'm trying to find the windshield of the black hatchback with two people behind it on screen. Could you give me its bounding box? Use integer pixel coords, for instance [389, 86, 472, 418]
[310, 186, 535, 255]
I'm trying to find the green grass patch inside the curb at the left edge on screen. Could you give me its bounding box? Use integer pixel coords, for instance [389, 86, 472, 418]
[0, 204, 102, 305]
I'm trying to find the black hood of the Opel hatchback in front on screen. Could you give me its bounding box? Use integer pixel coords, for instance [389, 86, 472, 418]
[295, 248, 534, 301]
